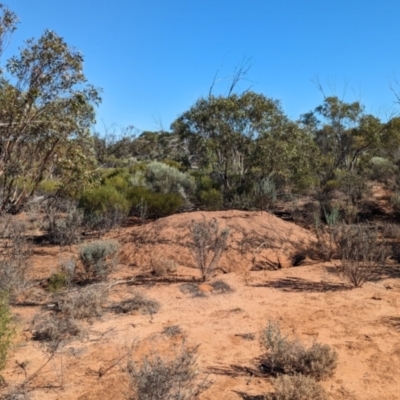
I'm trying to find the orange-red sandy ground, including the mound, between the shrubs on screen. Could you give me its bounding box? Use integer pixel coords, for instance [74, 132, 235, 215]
[3, 211, 400, 400]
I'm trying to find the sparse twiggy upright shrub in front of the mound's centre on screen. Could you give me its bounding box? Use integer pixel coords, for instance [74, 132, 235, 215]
[190, 219, 229, 281]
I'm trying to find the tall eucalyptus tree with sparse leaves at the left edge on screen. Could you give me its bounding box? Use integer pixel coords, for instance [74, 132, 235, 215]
[0, 5, 100, 212]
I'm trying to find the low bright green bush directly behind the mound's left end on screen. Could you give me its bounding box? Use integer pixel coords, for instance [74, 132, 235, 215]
[128, 186, 184, 218]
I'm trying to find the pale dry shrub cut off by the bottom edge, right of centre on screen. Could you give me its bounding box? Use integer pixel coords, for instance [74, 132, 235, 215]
[268, 375, 328, 400]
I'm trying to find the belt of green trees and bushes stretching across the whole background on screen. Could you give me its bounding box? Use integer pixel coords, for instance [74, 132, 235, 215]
[0, 4, 400, 217]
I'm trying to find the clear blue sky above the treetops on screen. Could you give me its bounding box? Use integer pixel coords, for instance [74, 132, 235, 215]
[3, 0, 400, 130]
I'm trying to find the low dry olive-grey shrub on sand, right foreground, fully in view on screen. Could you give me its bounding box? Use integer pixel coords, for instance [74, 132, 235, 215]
[261, 321, 337, 380]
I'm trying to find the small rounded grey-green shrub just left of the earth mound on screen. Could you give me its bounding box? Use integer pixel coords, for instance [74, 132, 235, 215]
[79, 240, 118, 280]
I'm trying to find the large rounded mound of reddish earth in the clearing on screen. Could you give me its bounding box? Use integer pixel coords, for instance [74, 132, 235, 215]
[121, 210, 316, 274]
